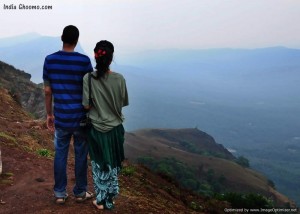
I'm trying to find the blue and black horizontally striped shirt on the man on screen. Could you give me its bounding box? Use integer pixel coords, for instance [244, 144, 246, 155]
[43, 51, 93, 131]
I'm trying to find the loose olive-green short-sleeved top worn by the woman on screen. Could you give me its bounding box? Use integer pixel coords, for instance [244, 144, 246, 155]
[82, 72, 129, 132]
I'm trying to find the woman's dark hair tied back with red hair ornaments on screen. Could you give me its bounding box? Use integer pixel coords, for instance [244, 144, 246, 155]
[94, 40, 114, 78]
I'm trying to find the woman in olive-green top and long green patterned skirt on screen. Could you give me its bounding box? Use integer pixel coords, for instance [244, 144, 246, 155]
[82, 40, 128, 209]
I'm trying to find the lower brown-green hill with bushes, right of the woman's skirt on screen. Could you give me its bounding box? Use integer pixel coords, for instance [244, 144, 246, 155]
[125, 129, 293, 206]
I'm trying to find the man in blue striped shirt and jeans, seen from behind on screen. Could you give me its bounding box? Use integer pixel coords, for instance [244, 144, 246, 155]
[43, 25, 93, 204]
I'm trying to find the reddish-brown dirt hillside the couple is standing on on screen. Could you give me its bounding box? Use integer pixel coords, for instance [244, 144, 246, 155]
[0, 88, 230, 214]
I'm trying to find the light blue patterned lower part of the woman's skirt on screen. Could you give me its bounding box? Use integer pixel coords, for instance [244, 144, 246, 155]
[91, 161, 120, 209]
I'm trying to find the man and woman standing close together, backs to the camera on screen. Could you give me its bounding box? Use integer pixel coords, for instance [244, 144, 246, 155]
[43, 25, 128, 209]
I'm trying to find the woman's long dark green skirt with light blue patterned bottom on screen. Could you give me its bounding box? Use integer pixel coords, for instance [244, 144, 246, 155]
[88, 124, 125, 209]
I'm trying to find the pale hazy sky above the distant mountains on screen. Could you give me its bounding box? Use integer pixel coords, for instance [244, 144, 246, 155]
[0, 0, 300, 52]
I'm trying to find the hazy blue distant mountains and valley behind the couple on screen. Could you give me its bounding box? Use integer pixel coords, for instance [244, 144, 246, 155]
[0, 34, 300, 206]
